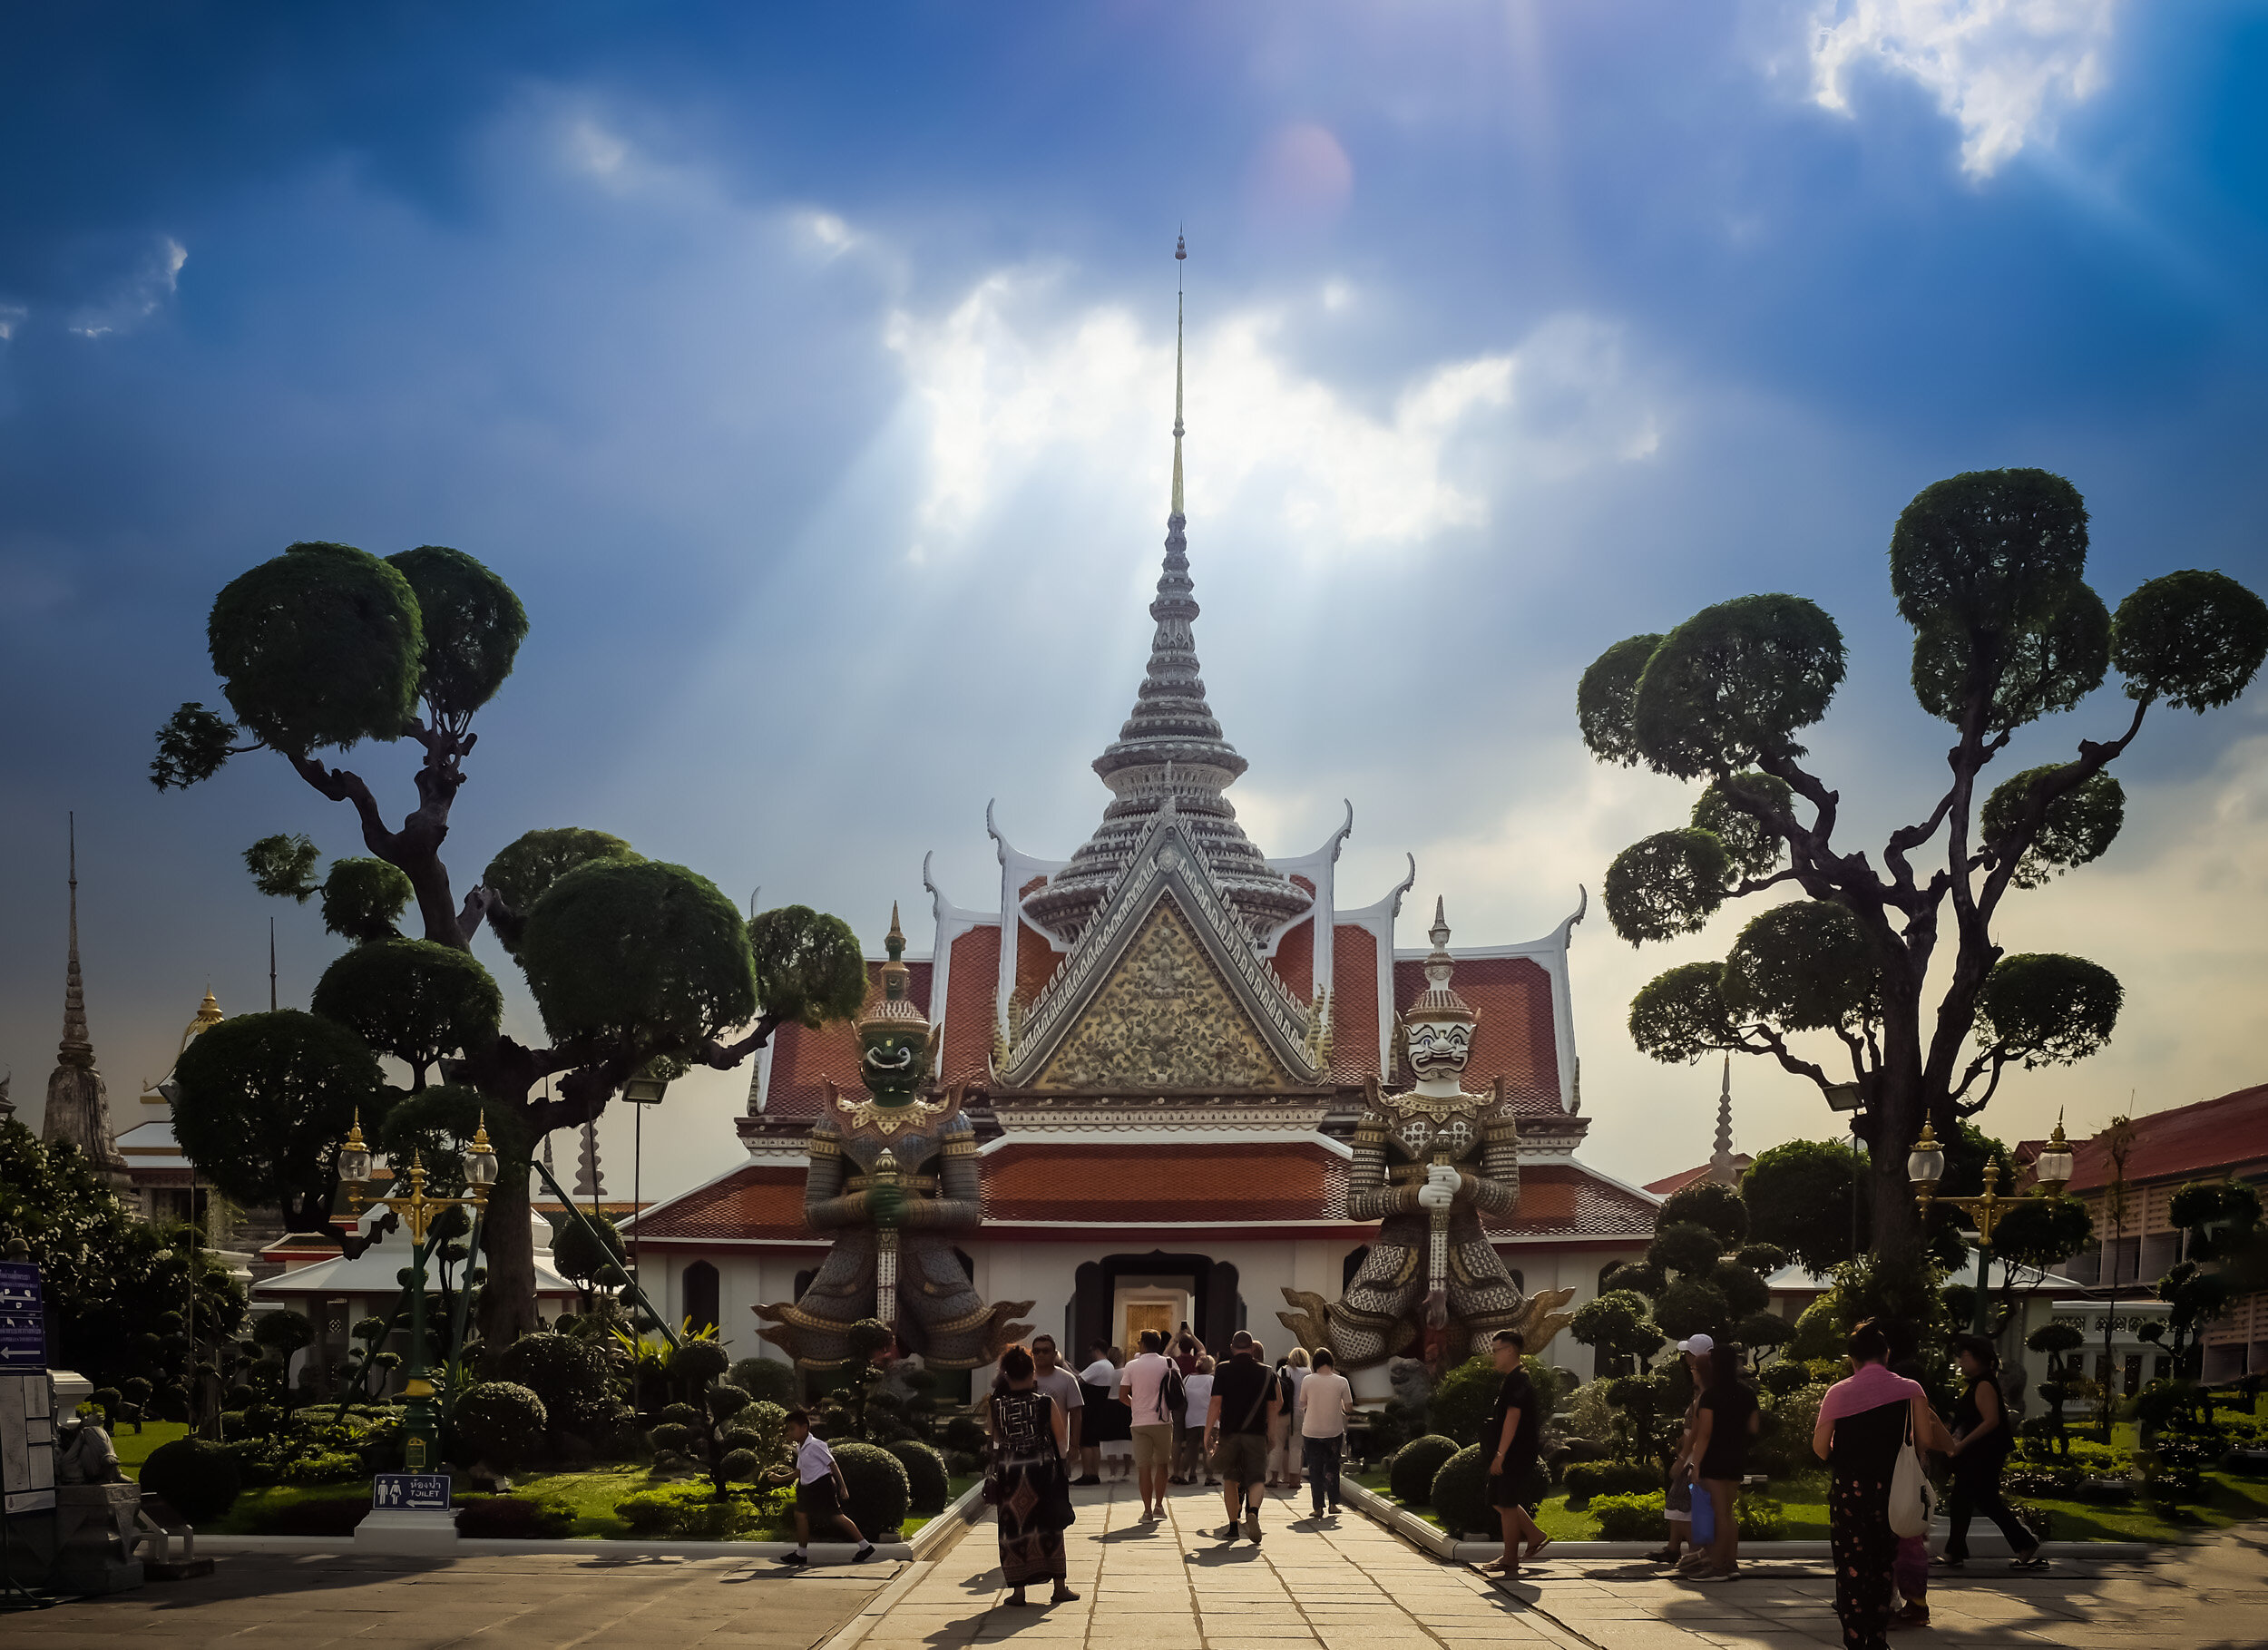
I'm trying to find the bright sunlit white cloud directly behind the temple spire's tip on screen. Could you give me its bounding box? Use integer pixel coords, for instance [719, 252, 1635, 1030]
[885, 269, 1660, 555]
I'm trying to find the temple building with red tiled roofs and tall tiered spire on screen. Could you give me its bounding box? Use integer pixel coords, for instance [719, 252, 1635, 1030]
[635, 278, 1660, 1376]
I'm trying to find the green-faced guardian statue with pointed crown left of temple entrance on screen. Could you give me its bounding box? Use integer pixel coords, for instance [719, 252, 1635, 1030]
[756, 909, 1032, 1369]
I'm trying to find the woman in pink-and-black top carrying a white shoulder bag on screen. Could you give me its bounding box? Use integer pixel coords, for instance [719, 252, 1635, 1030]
[1813, 1319, 1953, 1650]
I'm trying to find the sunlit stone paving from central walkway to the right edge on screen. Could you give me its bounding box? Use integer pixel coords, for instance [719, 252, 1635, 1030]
[885, 1487, 2268, 1650]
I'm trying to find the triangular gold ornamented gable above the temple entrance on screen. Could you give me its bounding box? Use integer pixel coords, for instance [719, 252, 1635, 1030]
[998, 800, 1329, 1095]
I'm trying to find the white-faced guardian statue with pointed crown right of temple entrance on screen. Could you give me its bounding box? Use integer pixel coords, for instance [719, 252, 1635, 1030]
[1277, 904, 1574, 1373]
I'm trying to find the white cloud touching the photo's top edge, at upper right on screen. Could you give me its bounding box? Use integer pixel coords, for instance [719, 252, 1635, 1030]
[1810, 0, 2118, 177]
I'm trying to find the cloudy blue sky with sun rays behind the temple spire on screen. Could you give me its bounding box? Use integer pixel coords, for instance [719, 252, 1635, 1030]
[0, 0, 2268, 1190]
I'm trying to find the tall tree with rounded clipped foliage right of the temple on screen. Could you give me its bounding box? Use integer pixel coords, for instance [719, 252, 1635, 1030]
[1577, 469, 2268, 1263]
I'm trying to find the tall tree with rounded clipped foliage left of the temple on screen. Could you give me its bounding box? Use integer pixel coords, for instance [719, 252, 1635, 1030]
[150, 544, 866, 1346]
